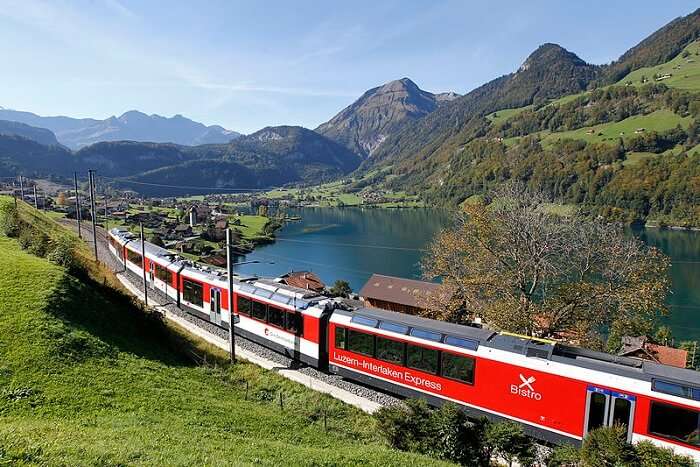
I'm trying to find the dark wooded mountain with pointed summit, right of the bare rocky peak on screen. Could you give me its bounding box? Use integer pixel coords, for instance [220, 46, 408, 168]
[363, 44, 598, 168]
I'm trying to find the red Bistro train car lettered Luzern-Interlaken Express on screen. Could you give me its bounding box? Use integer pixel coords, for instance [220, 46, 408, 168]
[328, 308, 700, 461]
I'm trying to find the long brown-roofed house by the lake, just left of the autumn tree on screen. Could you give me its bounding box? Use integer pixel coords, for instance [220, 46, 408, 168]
[360, 274, 440, 314]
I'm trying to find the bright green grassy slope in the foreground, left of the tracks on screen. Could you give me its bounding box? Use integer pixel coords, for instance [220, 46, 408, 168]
[0, 198, 446, 465]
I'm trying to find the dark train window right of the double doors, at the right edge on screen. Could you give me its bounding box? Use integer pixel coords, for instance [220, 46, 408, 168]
[649, 402, 700, 446]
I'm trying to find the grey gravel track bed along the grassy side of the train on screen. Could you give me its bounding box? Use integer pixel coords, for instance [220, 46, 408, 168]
[61, 220, 401, 405]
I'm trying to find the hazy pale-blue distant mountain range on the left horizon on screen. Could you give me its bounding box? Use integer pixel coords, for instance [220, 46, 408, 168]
[0, 109, 239, 149]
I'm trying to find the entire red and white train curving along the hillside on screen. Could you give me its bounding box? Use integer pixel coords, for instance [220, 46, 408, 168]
[110, 229, 700, 463]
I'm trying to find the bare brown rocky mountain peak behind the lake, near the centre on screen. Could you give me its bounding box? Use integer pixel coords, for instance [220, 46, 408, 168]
[316, 78, 459, 158]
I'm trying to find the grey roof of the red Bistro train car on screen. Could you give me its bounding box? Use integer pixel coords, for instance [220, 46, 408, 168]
[336, 307, 700, 387]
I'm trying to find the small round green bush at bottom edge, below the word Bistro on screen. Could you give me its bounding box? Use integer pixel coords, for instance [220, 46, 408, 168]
[485, 422, 535, 466]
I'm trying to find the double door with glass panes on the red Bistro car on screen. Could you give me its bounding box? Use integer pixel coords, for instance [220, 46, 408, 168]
[583, 386, 635, 441]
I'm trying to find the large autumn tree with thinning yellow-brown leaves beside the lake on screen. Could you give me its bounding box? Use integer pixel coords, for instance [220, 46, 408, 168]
[422, 185, 669, 345]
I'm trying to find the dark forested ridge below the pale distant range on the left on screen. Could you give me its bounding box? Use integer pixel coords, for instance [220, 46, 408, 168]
[0, 126, 361, 195]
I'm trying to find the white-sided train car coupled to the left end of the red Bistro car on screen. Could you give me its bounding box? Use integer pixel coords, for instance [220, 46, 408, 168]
[234, 279, 332, 368]
